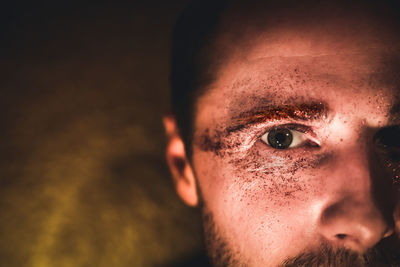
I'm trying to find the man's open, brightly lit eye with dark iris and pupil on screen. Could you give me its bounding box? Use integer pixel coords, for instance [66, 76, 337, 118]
[261, 128, 308, 149]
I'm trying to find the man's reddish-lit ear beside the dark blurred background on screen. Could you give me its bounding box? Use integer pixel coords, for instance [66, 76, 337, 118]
[163, 115, 199, 207]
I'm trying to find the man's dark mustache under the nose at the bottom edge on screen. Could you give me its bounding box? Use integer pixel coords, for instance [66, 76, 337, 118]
[279, 245, 400, 267]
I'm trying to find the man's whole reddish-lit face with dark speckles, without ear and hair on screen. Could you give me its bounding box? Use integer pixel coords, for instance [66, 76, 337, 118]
[192, 11, 400, 266]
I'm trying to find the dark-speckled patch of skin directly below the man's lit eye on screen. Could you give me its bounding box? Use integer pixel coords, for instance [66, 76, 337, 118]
[229, 141, 329, 202]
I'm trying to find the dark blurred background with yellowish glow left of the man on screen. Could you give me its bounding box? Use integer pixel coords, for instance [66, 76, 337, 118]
[0, 0, 202, 267]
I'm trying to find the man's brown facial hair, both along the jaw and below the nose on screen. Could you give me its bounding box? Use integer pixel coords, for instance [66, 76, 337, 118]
[202, 205, 400, 267]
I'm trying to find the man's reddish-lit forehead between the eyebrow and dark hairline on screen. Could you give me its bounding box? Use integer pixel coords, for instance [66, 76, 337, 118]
[197, 8, 400, 128]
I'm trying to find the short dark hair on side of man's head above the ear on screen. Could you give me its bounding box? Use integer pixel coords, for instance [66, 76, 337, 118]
[170, 0, 228, 158]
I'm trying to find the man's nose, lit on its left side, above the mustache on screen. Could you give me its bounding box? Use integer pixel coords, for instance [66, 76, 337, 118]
[319, 147, 393, 253]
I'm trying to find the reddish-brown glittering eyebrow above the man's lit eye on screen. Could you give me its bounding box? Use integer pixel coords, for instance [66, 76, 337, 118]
[227, 102, 329, 133]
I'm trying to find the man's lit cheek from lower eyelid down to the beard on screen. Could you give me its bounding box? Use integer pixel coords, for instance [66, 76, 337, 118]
[197, 149, 326, 264]
